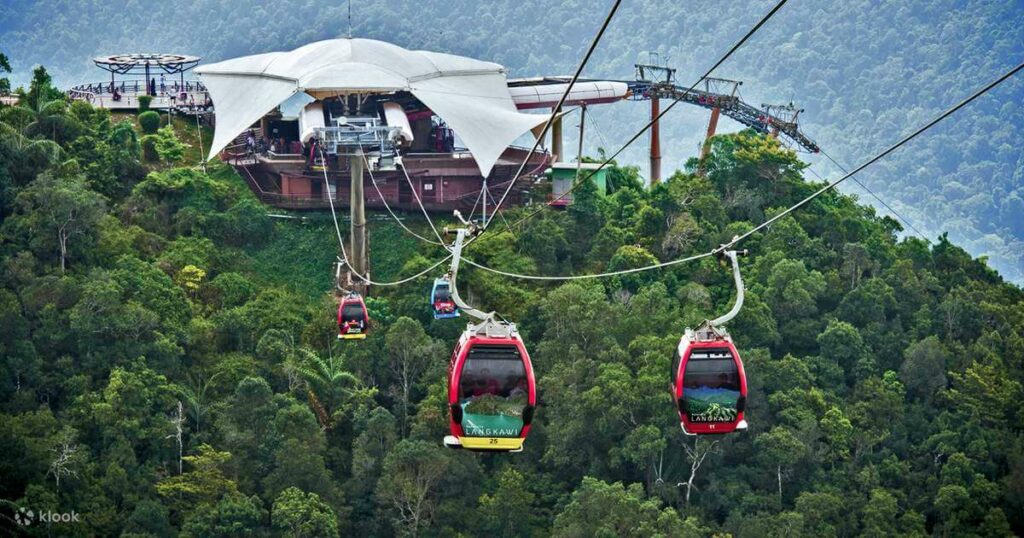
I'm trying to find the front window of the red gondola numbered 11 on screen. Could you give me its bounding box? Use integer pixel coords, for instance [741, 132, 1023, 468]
[683, 348, 740, 422]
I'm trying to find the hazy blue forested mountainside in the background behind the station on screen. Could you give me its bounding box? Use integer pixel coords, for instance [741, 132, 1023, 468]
[0, 0, 1024, 284]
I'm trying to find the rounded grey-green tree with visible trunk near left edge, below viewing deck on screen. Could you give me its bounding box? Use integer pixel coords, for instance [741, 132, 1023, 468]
[10, 173, 105, 273]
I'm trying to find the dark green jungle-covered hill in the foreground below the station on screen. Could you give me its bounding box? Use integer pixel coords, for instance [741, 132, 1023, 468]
[0, 64, 1024, 538]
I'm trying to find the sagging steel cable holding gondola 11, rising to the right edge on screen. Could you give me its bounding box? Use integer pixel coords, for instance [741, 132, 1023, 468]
[444, 64, 1024, 281]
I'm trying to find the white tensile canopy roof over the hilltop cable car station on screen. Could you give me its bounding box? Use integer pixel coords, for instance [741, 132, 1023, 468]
[196, 39, 546, 175]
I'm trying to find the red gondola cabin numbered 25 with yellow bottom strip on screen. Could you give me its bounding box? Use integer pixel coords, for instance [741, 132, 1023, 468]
[444, 322, 537, 452]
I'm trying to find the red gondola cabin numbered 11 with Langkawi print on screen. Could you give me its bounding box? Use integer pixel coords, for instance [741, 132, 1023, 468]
[673, 330, 746, 434]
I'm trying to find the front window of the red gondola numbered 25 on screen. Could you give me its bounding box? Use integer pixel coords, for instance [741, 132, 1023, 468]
[459, 344, 529, 438]
